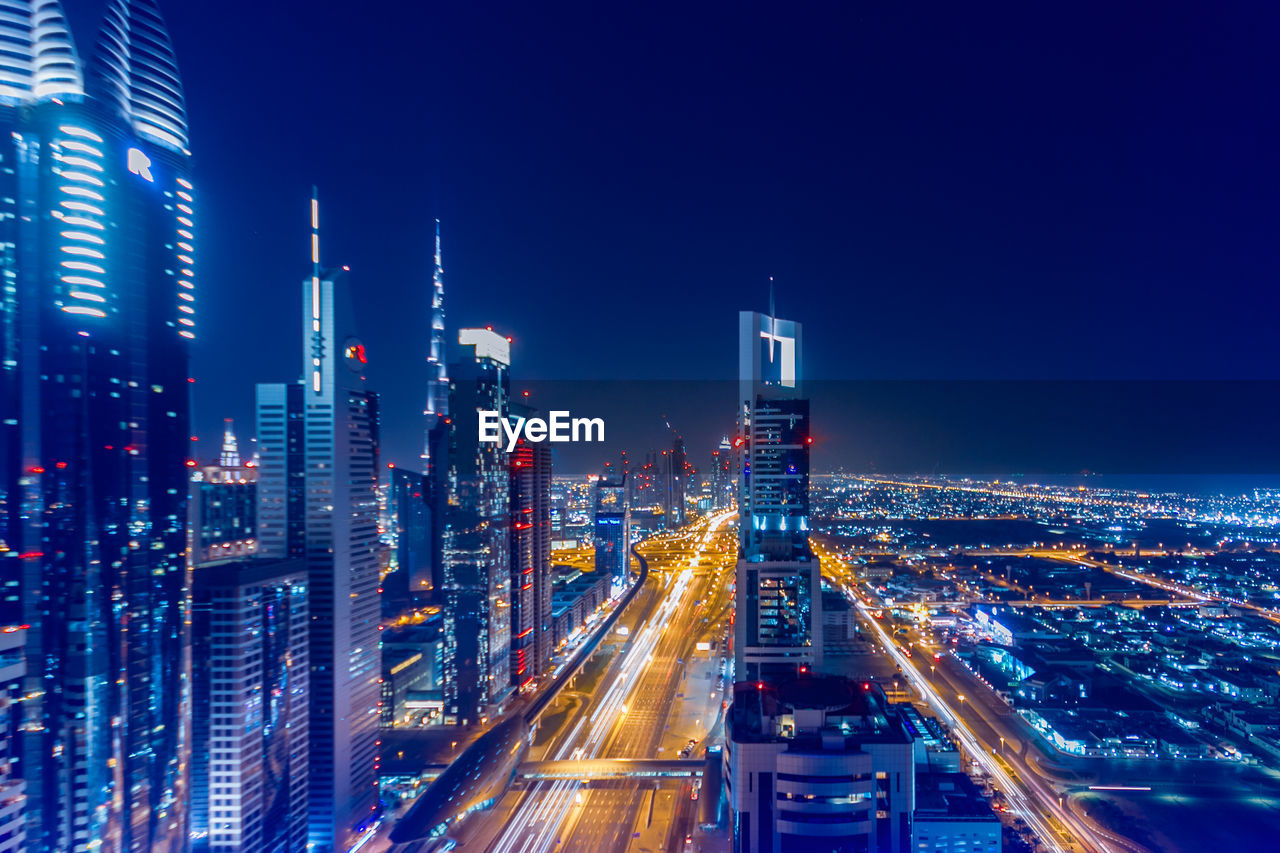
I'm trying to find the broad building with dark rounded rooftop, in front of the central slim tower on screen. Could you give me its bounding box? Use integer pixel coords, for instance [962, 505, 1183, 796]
[723, 675, 915, 853]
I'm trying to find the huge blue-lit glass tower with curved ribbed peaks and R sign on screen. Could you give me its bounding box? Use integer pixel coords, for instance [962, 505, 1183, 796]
[0, 0, 196, 852]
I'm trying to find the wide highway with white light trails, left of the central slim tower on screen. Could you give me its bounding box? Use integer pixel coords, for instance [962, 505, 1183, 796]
[481, 512, 736, 853]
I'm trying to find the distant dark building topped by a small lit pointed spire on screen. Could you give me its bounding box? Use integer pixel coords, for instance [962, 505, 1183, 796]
[188, 418, 257, 565]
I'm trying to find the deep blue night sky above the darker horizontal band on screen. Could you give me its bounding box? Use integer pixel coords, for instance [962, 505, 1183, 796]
[127, 0, 1280, 462]
